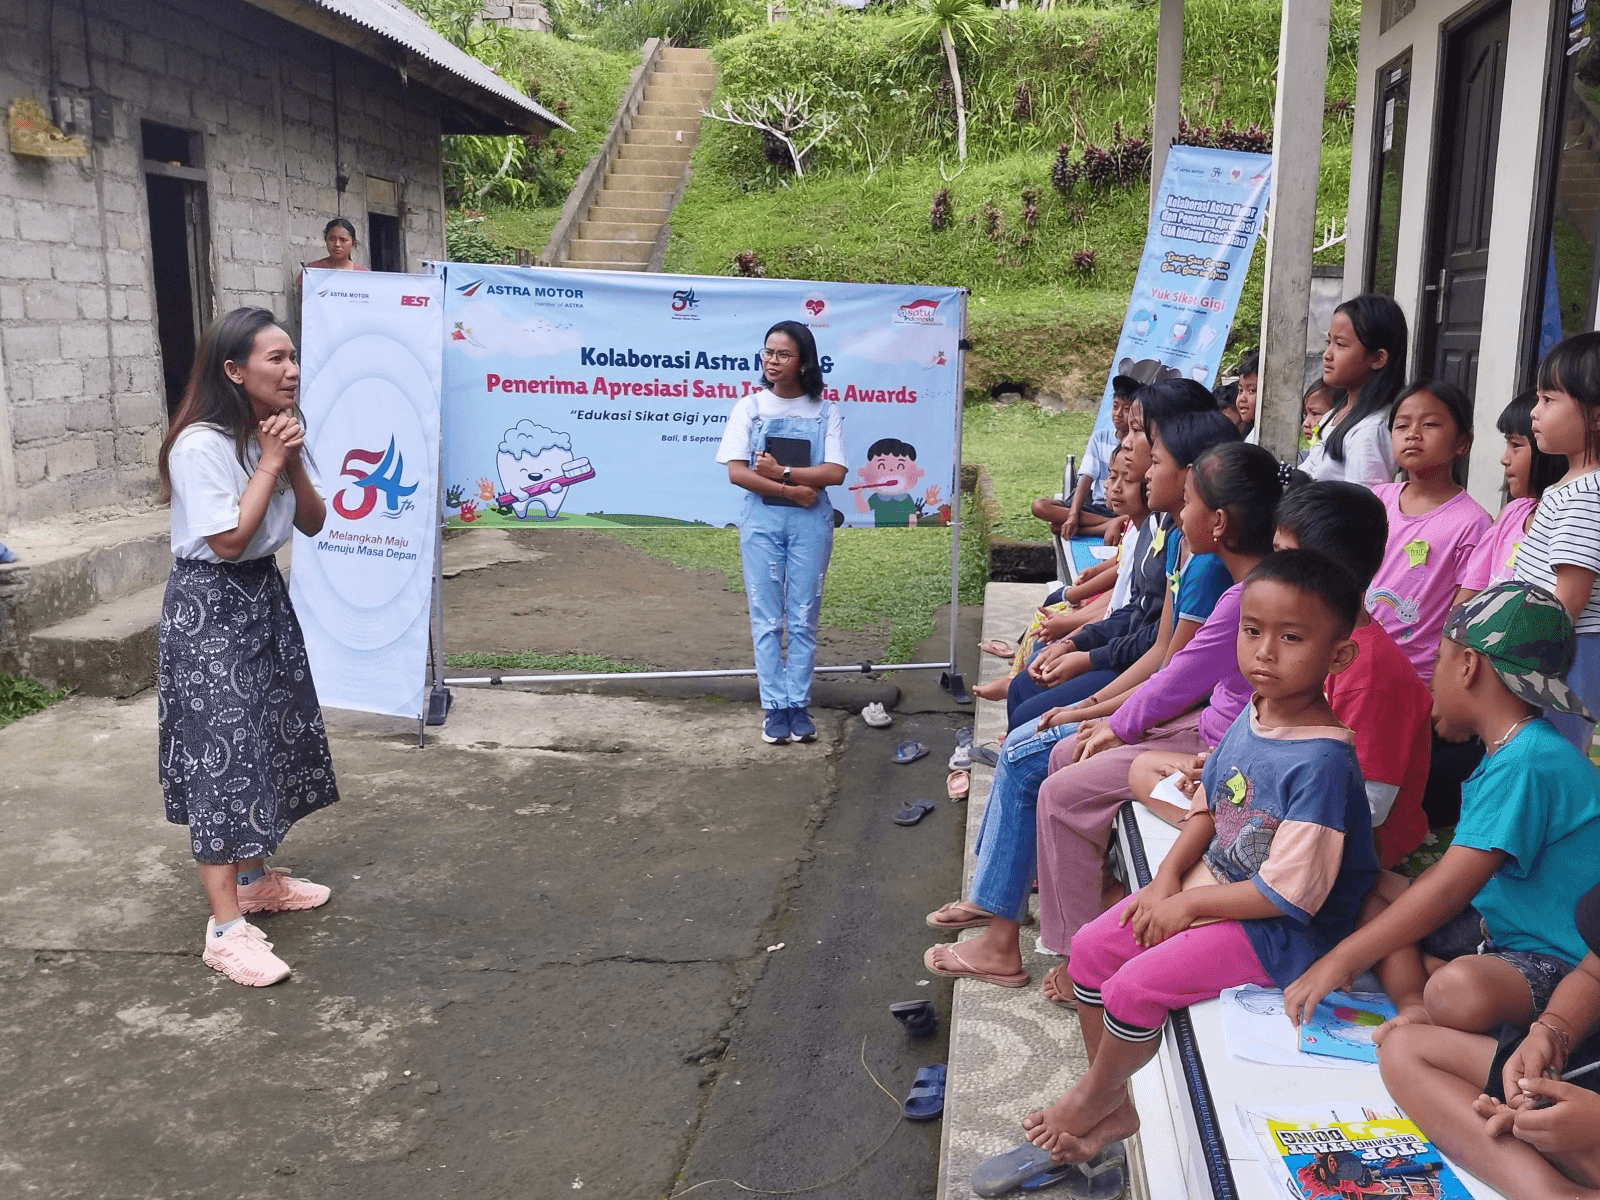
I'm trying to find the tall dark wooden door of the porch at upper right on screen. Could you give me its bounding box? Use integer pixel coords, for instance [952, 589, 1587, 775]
[1418, 5, 1510, 395]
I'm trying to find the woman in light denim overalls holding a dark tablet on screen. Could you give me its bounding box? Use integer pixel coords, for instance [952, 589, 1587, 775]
[717, 322, 850, 746]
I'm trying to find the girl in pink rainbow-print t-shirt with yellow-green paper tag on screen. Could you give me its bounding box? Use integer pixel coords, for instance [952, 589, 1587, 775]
[1366, 379, 1490, 683]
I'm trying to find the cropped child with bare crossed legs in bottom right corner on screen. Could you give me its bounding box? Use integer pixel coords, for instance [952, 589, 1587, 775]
[1378, 883, 1600, 1200]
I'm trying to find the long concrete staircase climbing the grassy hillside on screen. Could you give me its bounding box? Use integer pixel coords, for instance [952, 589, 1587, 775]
[558, 46, 717, 270]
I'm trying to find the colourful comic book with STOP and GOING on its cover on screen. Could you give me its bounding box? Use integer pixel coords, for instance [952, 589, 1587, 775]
[1250, 1104, 1472, 1200]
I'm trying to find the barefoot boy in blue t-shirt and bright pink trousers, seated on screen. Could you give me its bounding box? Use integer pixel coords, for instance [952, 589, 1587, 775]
[1022, 550, 1378, 1162]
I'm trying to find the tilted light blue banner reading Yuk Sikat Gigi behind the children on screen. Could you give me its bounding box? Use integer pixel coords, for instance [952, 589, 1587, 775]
[1094, 146, 1272, 427]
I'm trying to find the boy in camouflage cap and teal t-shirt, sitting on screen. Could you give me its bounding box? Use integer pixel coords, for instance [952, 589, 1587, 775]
[1283, 582, 1600, 1032]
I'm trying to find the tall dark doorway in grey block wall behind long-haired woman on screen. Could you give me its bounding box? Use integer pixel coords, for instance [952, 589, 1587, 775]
[141, 122, 211, 414]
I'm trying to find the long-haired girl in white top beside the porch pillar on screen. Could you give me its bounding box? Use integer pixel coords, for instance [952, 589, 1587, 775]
[1301, 294, 1406, 488]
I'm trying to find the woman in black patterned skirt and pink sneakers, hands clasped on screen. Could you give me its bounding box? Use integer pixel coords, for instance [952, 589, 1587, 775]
[157, 309, 339, 987]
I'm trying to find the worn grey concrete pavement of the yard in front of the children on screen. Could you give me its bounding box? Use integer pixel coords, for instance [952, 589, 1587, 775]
[0, 595, 976, 1200]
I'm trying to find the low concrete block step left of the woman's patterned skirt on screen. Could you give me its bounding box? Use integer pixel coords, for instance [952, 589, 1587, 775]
[24, 584, 166, 698]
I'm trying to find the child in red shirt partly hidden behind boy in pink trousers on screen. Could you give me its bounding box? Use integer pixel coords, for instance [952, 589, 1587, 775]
[1128, 480, 1434, 867]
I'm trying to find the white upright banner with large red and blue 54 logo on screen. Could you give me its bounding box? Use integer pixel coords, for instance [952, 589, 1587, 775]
[290, 270, 445, 717]
